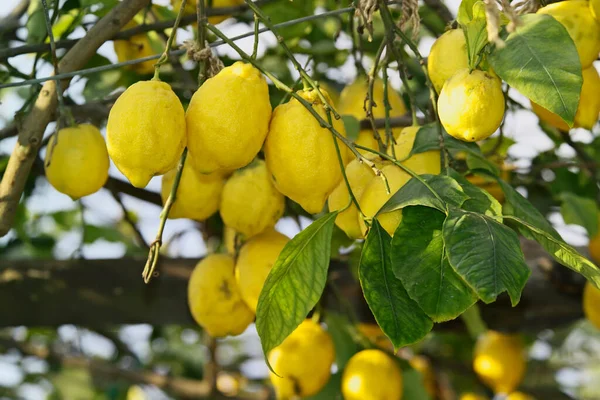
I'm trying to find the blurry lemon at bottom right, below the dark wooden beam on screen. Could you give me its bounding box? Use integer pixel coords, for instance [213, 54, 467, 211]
[473, 331, 526, 393]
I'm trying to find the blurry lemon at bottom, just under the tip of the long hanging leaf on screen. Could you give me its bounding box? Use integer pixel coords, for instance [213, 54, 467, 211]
[269, 319, 335, 400]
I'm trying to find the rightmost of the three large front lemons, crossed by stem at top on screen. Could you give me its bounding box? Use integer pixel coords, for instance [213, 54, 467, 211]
[265, 89, 348, 214]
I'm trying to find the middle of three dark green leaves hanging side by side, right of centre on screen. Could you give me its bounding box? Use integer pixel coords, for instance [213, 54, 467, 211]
[391, 206, 477, 322]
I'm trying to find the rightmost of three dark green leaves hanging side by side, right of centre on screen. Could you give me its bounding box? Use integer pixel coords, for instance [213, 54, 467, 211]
[443, 209, 531, 306]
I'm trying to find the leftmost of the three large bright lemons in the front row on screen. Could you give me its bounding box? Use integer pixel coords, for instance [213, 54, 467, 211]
[106, 81, 186, 188]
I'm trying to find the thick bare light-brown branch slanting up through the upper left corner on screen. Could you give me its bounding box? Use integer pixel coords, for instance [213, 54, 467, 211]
[0, 0, 150, 236]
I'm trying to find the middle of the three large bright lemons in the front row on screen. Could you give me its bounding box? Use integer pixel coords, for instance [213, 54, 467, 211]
[186, 61, 271, 173]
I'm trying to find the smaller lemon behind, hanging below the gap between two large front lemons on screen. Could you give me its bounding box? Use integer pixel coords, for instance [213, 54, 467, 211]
[221, 160, 285, 238]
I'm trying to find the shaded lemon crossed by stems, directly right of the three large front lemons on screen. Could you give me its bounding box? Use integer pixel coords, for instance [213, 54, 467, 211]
[328, 159, 375, 239]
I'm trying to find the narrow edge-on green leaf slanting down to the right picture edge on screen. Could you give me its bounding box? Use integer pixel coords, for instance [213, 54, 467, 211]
[505, 216, 600, 288]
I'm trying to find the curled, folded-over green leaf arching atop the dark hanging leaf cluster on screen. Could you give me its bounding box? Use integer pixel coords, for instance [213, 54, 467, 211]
[378, 175, 468, 214]
